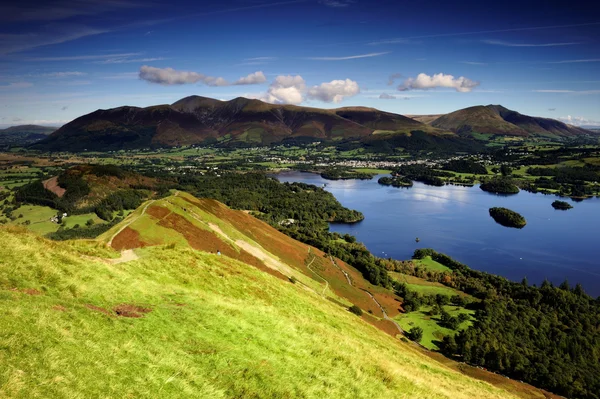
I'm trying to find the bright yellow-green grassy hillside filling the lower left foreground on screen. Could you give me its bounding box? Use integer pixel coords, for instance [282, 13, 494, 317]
[0, 228, 512, 398]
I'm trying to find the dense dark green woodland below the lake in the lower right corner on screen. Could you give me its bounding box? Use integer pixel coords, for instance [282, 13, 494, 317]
[408, 249, 600, 399]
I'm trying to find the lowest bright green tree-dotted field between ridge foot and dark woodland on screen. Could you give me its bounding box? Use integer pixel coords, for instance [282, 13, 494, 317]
[395, 306, 475, 350]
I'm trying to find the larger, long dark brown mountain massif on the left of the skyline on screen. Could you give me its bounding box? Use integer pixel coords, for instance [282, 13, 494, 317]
[34, 96, 443, 151]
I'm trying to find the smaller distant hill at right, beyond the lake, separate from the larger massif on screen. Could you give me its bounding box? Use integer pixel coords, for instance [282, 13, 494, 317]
[421, 105, 593, 138]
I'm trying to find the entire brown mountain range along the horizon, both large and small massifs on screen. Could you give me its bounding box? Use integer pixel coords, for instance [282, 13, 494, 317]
[33, 96, 594, 151]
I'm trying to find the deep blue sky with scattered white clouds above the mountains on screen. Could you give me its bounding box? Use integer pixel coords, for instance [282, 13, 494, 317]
[0, 0, 600, 126]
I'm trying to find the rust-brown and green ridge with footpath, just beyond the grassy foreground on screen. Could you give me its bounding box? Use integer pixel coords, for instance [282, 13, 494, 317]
[99, 192, 400, 326]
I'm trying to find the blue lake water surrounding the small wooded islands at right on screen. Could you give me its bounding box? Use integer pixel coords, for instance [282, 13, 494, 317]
[276, 172, 600, 297]
